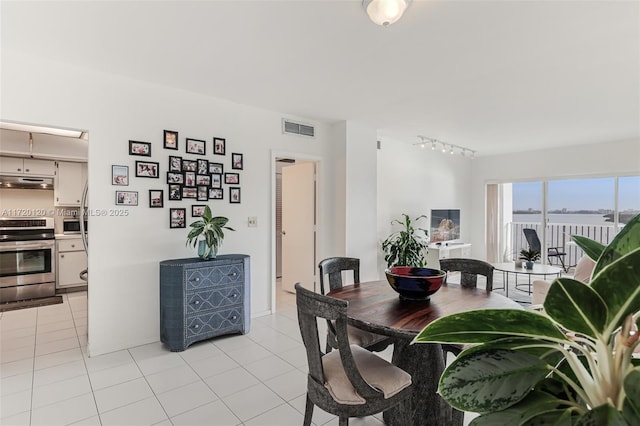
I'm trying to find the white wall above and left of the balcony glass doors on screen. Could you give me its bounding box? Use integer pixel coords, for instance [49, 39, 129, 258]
[469, 140, 640, 259]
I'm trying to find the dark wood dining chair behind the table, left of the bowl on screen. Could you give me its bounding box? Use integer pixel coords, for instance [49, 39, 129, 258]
[318, 257, 393, 353]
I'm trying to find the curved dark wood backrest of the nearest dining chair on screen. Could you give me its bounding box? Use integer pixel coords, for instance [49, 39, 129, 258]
[295, 283, 384, 399]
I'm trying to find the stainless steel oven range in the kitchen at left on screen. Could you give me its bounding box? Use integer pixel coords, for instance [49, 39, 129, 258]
[0, 218, 56, 303]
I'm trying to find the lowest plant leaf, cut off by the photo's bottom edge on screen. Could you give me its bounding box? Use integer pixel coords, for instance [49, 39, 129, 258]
[470, 391, 571, 426]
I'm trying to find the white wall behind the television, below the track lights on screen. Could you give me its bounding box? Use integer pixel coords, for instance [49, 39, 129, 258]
[377, 140, 475, 276]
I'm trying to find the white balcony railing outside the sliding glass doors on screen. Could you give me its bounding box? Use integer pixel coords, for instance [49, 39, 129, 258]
[509, 222, 624, 267]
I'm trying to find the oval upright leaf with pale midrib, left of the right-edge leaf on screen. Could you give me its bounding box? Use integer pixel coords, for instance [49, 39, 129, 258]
[544, 278, 607, 338]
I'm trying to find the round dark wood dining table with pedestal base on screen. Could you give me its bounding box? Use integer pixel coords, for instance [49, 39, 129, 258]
[328, 280, 523, 426]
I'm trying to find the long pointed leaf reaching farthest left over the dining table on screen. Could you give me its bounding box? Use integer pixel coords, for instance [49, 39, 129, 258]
[413, 309, 567, 343]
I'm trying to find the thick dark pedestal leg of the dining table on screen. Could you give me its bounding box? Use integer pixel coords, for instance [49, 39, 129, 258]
[383, 340, 464, 426]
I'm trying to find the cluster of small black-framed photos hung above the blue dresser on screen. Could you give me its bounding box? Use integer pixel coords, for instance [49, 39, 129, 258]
[111, 130, 244, 228]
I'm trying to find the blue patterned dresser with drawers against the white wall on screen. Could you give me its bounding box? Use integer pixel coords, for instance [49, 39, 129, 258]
[160, 254, 251, 351]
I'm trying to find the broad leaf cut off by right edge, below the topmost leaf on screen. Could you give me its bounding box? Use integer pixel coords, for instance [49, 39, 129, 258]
[588, 248, 640, 327]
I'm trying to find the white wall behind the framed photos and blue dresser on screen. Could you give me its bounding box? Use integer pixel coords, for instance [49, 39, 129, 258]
[0, 50, 344, 355]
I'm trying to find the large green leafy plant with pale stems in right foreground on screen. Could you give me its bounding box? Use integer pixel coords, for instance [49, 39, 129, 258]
[414, 215, 640, 426]
